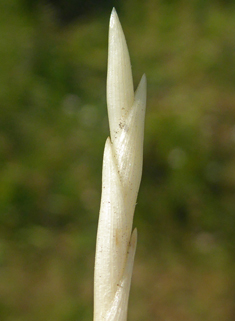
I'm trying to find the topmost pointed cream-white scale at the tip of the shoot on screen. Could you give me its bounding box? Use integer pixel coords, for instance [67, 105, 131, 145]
[107, 5, 134, 142]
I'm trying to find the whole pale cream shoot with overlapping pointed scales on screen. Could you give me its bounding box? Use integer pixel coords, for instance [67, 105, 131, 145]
[94, 9, 146, 321]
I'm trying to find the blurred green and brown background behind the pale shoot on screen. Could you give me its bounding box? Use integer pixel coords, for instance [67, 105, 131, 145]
[0, 0, 235, 321]
